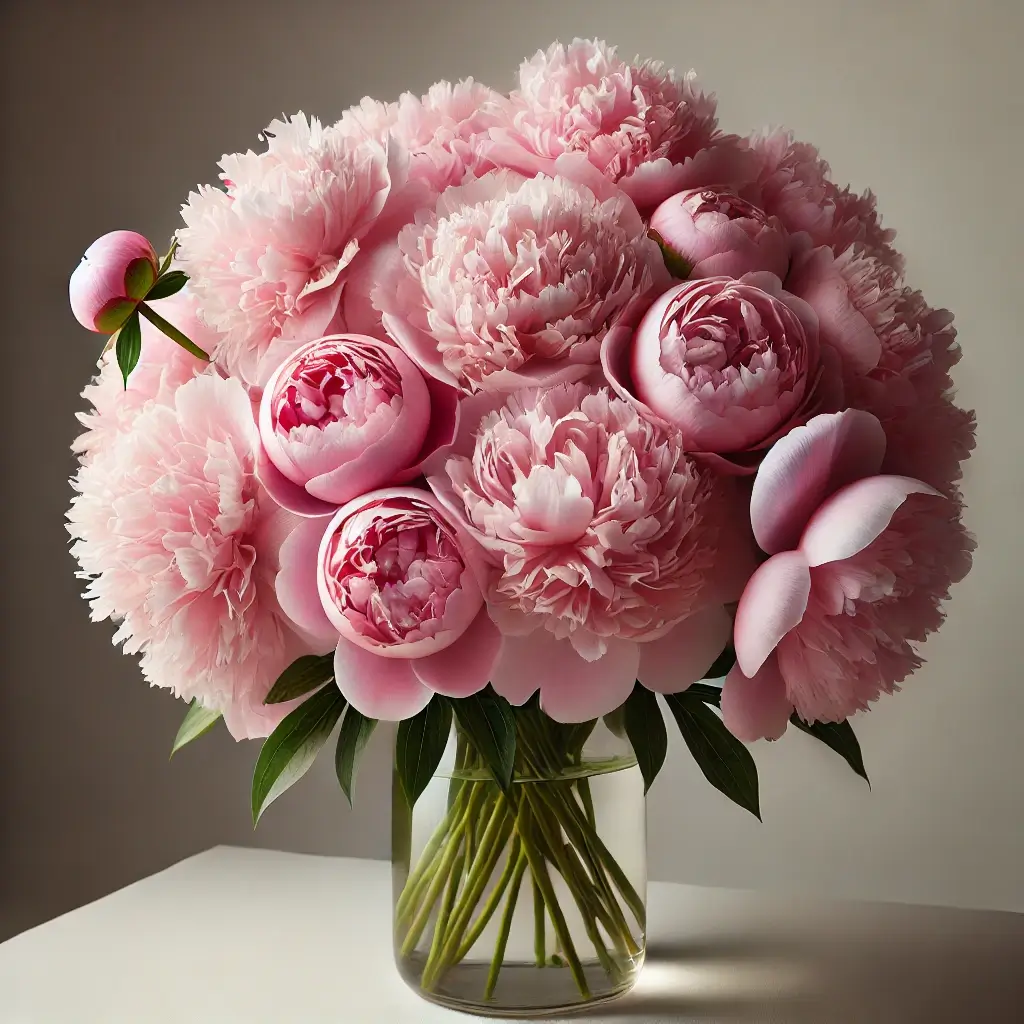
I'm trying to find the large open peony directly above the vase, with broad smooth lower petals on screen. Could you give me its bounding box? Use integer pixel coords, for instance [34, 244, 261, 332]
[427, 383, 729, 721]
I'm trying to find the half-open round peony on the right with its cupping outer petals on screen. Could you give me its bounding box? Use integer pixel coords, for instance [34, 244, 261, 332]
[602, 272, 838, 473]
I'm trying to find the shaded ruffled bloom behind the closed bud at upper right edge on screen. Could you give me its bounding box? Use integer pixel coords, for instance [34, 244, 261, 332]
[743, 129, 903, 271]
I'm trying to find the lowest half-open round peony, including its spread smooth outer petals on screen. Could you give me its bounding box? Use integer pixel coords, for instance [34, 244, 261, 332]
[276, 487, 501, 721]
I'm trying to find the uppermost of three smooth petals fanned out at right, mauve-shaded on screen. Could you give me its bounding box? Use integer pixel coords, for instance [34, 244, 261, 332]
[751, 409, 886, 554]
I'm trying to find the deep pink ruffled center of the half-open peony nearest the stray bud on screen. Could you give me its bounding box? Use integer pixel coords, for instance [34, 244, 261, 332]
[273, 342, 401, 433]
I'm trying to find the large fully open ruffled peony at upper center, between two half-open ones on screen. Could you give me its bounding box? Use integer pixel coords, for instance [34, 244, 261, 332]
[373, 171, 668, 392]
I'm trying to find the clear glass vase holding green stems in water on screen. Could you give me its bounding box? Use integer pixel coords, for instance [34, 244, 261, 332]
[392, 706, 647, 1017]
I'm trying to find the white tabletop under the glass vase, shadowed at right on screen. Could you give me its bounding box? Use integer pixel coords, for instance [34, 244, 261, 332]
[0, 847, 1024, 1024]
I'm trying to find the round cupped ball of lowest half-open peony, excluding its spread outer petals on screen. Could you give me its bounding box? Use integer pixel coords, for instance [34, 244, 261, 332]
[325, 498, 466, 644]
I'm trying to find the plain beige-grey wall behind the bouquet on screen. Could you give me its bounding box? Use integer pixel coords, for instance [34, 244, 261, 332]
[0, 0, 1024, 937]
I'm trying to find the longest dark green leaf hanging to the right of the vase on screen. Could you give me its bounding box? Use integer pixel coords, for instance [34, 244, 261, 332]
[665, 687, 761, 820]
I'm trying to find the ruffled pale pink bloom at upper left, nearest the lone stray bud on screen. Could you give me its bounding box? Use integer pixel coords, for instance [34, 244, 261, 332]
[178, 114, 415, 386]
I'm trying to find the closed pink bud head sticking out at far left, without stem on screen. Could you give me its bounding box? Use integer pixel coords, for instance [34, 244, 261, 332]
[69, 231, 160, 334]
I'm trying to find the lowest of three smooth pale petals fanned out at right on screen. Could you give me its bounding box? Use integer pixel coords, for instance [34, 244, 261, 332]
[733, 551, 811, 676]
